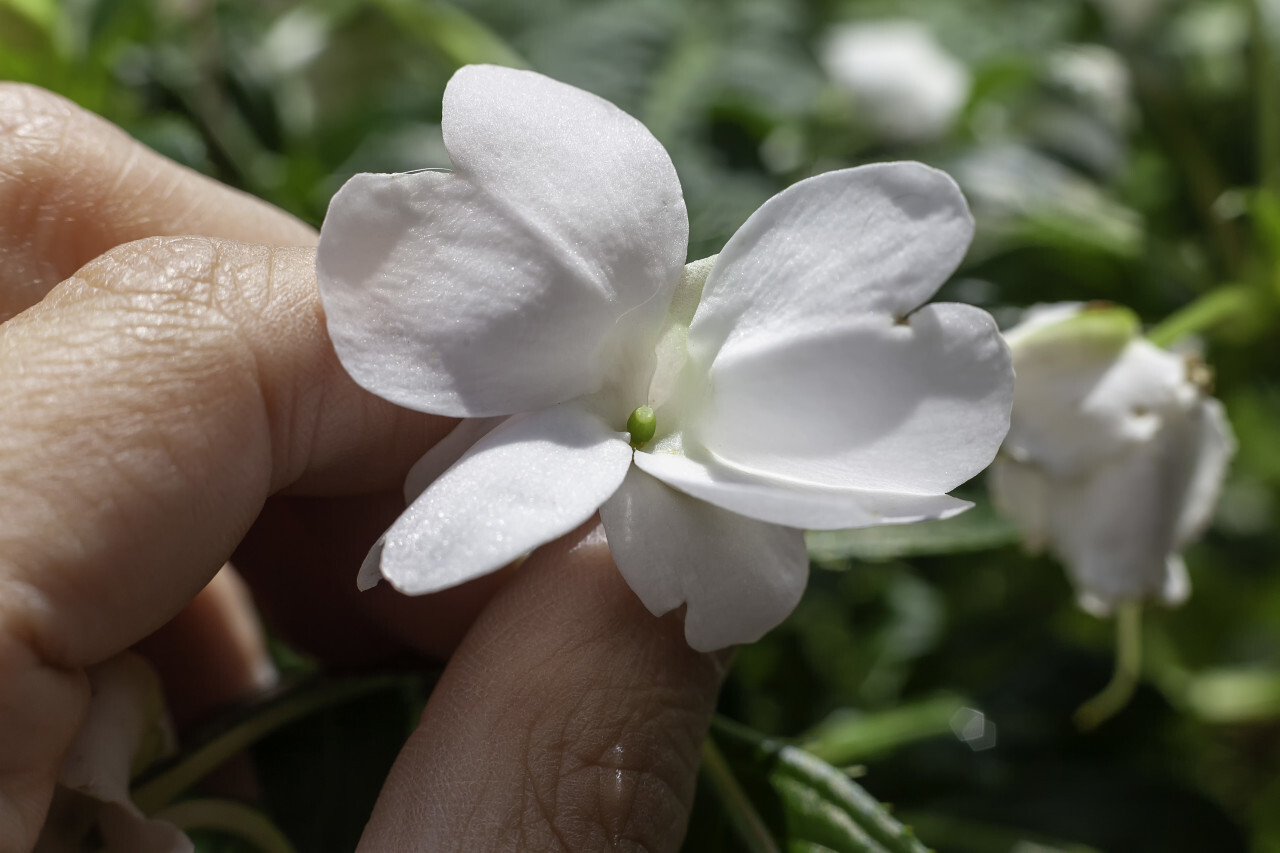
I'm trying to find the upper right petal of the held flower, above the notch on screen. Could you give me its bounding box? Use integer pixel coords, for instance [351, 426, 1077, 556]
[689, 163, 973, 368]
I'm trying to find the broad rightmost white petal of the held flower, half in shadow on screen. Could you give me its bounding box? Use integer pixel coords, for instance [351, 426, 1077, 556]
[686, 304, 1014, 494]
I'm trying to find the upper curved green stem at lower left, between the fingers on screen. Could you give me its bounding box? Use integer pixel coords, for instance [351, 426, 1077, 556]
[133, 676, 403, 815]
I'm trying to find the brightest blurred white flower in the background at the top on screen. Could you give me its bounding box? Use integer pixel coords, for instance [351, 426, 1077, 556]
[819, 19, 970, 142]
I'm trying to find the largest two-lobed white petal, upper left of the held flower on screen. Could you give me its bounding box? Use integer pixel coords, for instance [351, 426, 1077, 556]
[316, 65, 689, 416]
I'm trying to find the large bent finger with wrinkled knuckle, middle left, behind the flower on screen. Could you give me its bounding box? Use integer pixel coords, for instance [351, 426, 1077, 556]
[0, 238, 452, 850]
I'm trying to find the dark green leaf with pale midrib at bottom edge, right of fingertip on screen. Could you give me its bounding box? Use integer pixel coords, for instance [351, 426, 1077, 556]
[703, 717, 927, 853]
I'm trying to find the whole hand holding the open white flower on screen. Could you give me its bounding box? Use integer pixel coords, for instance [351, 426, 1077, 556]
[0, 83, 723, 853]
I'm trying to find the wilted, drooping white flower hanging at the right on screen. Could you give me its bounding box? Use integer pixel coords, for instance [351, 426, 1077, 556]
[991, 304, 1234, 615]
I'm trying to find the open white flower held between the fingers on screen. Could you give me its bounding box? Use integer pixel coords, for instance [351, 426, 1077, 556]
[317, 67, 1012, 649]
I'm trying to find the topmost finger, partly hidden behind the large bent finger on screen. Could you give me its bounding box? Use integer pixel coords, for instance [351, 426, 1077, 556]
[0, 83, 315, 320]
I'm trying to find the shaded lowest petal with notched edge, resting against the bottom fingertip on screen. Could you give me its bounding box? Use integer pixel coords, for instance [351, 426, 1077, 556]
[600, 467, 809, 652]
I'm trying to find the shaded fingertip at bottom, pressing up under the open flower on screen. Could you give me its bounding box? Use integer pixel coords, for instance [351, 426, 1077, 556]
[360, 517, 723, 853]
